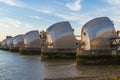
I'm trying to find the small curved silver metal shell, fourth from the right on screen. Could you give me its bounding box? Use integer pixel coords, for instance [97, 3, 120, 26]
[13, 35, 24, 47]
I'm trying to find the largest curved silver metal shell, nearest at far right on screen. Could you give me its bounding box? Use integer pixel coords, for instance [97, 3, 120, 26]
[81, 17, 116, 50]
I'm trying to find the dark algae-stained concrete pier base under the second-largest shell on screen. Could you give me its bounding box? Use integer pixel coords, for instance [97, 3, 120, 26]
[41, 48, 76, 59]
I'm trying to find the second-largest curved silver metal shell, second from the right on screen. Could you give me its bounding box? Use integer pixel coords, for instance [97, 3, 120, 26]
[46, 22, 77, 49]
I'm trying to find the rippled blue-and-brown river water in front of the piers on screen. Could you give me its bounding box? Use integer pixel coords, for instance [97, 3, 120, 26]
[0, 50, 120, 80]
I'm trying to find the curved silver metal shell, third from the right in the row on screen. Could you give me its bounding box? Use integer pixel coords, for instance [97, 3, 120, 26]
[24, 30, 42, 48]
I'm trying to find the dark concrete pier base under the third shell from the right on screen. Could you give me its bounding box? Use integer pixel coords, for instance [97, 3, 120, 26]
[19, 48, 41, 55]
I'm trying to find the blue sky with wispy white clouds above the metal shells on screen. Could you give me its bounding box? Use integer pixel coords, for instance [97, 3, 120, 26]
[0, 0, 120, 40]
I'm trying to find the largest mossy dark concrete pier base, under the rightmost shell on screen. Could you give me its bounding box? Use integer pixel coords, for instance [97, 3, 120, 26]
[76, 50, 120, 65]
